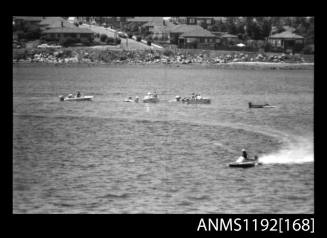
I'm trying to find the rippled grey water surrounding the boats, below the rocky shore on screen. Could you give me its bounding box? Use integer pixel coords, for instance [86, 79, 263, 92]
[13, 66, 314, 213]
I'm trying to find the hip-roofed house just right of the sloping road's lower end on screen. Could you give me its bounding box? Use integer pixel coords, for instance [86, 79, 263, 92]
[178, 28, 217, 49]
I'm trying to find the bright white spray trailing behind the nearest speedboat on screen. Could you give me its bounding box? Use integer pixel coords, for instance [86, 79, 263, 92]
[259, 138, 314, 164]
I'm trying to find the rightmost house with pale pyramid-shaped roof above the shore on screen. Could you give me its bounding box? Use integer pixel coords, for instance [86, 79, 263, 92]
[268, 31, 304, 52]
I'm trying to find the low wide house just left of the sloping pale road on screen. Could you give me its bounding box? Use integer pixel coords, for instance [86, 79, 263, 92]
[42, 27, 94, 43]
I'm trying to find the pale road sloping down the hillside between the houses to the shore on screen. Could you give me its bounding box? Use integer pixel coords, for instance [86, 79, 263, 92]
[80, 24, 161, 50]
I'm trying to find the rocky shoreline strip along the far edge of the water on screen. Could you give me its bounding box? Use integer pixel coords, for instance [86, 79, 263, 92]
[13, 47, 314, 69]
